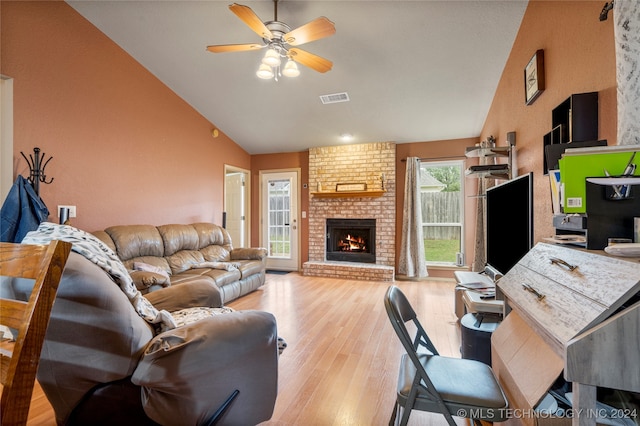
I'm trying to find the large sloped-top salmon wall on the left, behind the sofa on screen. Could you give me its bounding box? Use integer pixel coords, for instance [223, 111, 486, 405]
[0, 1, 251, 231]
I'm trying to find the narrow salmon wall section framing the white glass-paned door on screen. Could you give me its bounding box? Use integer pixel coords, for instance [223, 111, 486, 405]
[251, 151, 309, 264]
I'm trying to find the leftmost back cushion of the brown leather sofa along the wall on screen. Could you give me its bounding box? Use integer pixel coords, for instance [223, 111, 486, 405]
[105, 225, 165, 262]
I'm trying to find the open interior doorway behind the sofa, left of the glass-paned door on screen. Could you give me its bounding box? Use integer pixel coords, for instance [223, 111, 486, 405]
[224, 165, 251, 248]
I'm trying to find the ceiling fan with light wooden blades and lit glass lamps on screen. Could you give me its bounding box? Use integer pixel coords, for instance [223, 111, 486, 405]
[207, 0, 336, 80]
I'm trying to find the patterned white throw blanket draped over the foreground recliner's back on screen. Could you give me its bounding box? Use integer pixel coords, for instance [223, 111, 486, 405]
[22, 222, 176, 332]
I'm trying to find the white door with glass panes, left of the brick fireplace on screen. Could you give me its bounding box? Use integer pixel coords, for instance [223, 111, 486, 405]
[261, 171, 299, 271]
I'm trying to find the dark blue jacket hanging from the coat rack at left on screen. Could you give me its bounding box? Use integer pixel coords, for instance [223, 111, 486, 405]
[0, 175, 49, 243]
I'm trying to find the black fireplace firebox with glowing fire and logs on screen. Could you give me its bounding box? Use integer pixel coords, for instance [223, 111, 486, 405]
[326, 219, 376, 263]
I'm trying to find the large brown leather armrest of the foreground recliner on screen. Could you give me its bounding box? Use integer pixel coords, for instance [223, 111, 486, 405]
[132, 311, 278, 425]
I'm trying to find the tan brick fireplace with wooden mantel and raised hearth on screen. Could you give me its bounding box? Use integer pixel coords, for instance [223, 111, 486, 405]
[303, 142, 396, 281]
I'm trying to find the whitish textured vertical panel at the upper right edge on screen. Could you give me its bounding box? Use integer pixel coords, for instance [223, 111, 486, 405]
[613, 0, 640, 145]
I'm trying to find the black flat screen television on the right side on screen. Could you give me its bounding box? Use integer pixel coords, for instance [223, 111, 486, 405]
[486, 172, 533, 279]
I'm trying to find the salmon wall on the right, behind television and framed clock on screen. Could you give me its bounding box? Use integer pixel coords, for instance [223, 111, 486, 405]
[481, 0, 617, 245]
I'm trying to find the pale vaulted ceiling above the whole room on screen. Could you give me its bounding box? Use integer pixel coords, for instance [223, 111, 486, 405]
[68, 0, 527, 154]
